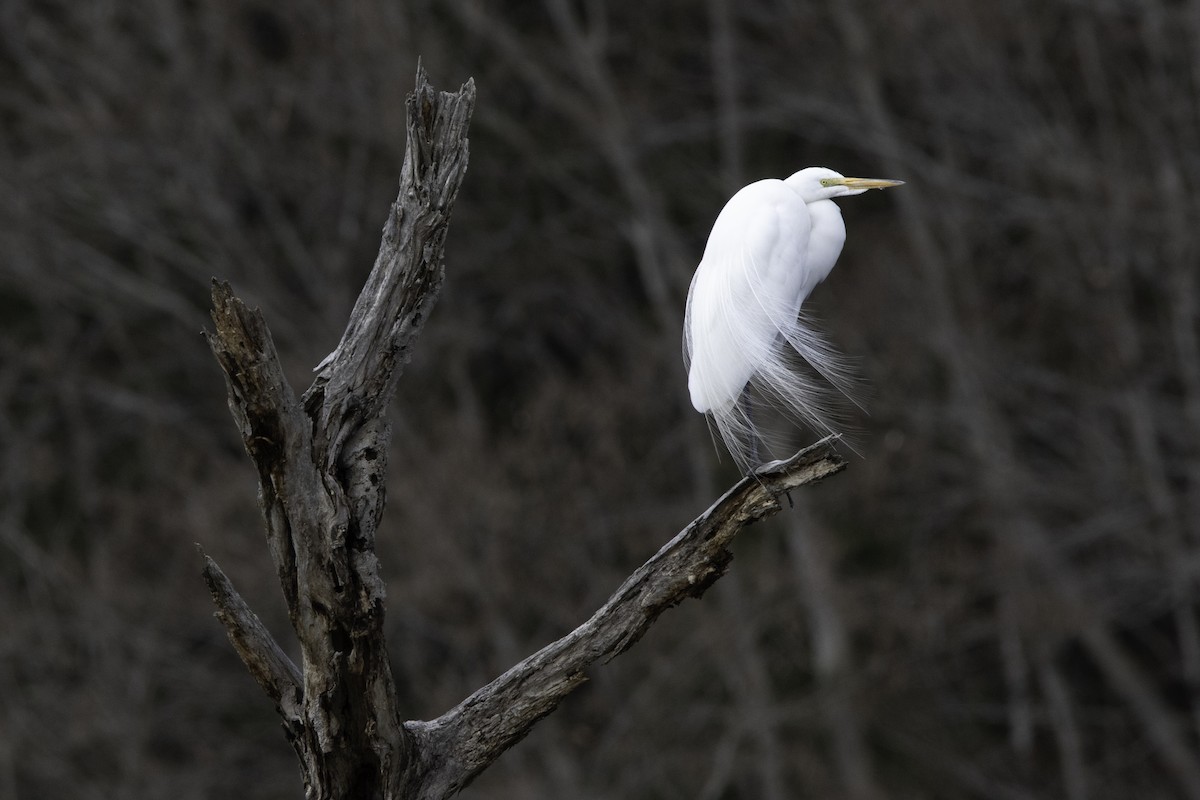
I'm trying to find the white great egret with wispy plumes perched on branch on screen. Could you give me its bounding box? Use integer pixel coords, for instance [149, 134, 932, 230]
[684, 167, 904, 474]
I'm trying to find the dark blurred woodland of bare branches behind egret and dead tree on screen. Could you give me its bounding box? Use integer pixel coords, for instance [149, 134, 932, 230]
[0, 0, 1200, 800]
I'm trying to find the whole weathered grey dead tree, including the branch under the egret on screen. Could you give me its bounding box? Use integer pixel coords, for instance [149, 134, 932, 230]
[204, 70, 844, 800]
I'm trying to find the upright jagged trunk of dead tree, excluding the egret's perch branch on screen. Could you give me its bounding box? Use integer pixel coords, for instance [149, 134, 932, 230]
[205, 72, 475, 800]
